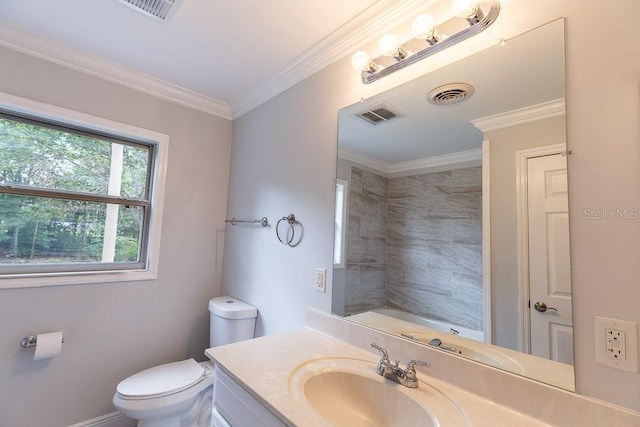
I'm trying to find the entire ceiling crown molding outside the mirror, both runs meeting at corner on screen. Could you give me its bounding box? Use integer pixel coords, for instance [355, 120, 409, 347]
[0, 0, 438, 120]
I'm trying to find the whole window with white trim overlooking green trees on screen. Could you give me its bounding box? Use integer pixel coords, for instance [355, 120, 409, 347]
[0, 94, 168, 287]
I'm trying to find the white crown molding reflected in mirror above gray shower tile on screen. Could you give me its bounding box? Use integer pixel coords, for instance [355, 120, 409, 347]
[338, 149, 482, 178]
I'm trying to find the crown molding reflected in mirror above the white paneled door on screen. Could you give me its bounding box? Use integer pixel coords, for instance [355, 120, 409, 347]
[471, 98, 565, 132]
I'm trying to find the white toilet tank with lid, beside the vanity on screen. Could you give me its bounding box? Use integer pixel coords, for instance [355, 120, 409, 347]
[209, 296, 258, 347]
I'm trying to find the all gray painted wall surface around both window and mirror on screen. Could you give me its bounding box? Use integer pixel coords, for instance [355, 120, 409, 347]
[0, 0, 640, 426]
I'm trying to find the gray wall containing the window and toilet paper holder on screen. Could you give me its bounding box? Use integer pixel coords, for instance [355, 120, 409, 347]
[0, 49, 231, 427]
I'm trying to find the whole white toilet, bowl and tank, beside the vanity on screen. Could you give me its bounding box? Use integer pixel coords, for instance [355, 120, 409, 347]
[113, 296, 258, 427]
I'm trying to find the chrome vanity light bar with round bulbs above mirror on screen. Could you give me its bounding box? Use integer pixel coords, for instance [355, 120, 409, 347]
[351, 0, 500, 84]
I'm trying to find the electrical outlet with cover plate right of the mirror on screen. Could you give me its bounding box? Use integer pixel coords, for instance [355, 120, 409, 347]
[594, 317, 638, 373]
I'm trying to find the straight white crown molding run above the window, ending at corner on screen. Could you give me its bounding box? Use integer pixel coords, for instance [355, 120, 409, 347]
[0, 25, 232, 120]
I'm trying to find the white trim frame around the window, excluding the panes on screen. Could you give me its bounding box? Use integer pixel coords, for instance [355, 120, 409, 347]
[0, 92, 169, 289]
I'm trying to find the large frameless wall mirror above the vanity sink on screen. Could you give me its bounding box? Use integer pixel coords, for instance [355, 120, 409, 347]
[332, 19, 574, 390]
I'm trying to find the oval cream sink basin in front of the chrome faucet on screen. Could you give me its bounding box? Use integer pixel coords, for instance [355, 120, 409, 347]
[289, 358, 469, 427]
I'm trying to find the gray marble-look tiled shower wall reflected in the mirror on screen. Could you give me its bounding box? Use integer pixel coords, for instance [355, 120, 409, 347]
[346, 167, 483, 330]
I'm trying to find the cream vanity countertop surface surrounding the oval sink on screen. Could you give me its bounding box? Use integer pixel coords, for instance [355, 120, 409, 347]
[205, 328, 548, 427]
